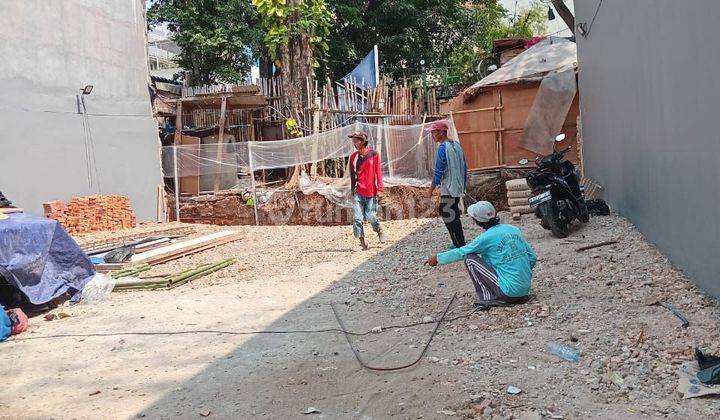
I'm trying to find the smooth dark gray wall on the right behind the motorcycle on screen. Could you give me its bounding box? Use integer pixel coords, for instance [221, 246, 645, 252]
[575, 0, 720, 297]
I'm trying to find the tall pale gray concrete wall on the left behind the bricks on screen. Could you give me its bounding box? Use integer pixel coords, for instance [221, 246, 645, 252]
[0, 0, 162, 220]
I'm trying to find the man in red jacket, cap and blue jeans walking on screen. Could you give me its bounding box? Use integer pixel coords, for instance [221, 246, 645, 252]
[348, 131, 385, 249]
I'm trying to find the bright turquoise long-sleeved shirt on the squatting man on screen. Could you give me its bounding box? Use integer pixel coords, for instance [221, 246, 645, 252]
[437, 224, 537, 297]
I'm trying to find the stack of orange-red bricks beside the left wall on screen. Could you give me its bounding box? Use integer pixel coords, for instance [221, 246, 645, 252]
[43, 195, 137, 233]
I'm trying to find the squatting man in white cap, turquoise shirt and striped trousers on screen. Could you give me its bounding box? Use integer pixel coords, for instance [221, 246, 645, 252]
[426, 201, 537, 305]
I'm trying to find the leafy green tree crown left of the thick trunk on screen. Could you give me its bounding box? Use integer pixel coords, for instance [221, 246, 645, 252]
[148, 0, 263, 84]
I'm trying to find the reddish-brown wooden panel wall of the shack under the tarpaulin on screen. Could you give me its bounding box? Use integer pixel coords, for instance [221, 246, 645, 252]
[450, 83, 580, 169]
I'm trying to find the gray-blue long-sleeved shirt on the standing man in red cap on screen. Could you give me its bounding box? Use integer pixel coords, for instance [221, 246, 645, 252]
[432, 139, 467, 197]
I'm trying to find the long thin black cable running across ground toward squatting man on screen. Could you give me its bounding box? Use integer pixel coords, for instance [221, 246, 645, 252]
[10, 293, 480, 341]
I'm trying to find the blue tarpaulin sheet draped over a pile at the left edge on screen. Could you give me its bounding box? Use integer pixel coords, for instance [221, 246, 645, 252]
[0, 214, 95, 305]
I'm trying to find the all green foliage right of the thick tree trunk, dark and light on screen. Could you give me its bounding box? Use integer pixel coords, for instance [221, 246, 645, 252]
[326, 0, 547, 81]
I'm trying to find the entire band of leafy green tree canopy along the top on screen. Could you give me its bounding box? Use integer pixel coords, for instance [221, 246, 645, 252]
[148, 0, 547, 84]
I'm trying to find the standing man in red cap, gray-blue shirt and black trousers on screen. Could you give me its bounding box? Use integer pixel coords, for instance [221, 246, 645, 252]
[425, 120, 467, 248]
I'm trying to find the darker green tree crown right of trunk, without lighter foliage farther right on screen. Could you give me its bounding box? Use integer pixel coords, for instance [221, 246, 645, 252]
[326, 0, 475, 78]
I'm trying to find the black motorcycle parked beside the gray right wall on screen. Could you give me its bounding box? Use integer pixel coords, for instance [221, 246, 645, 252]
[520, 134, 590, 238]
